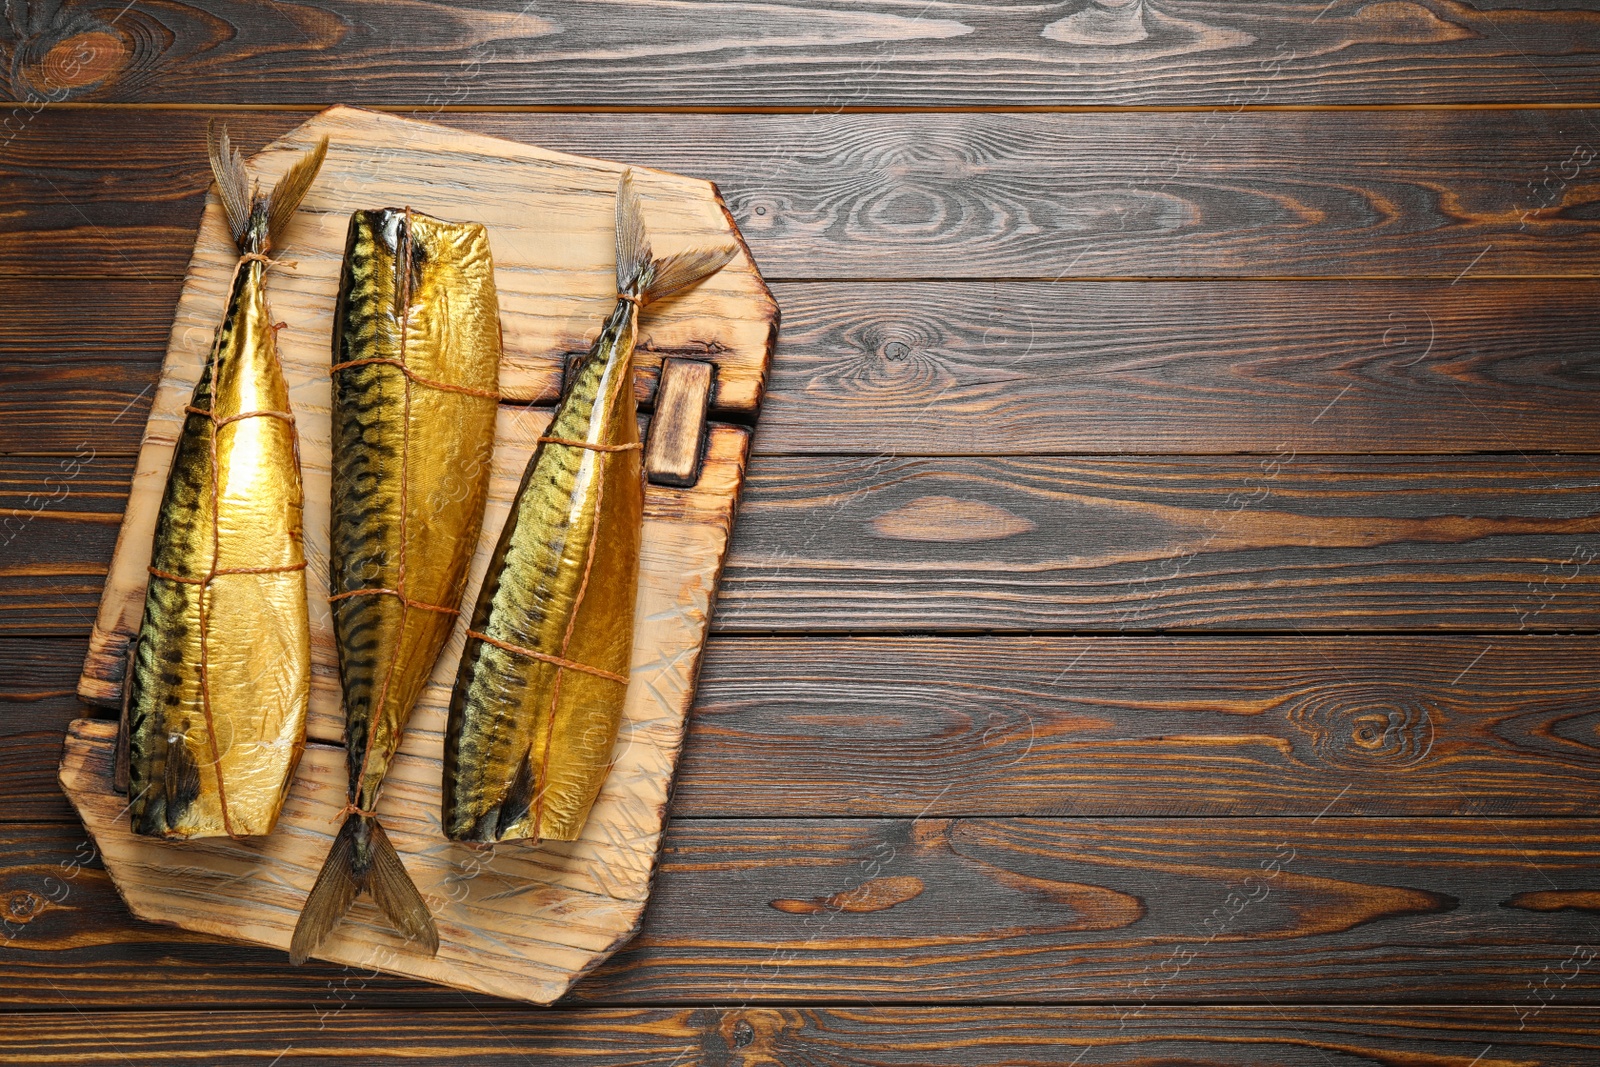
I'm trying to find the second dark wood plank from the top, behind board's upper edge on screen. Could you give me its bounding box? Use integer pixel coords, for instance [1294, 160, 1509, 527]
[0, 108, 1600, 282]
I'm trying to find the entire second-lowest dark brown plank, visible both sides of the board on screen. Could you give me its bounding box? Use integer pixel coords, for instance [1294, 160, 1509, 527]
[0, 825, 1600, 1011]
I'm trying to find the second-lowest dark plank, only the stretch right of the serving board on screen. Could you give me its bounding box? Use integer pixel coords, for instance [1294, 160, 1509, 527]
[518, 812, 1600, 1003]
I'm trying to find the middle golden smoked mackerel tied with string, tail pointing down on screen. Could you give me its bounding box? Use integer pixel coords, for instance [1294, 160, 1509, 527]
[290, 208, 501, 963]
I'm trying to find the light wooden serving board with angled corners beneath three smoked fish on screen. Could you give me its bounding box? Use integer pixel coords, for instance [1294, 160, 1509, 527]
[61, 107, 778, 1003]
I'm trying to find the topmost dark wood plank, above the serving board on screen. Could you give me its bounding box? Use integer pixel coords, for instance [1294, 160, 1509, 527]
[3, 0, 1600, 109]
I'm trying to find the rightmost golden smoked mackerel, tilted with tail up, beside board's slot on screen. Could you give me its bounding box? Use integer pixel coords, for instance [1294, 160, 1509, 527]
[443, 173, 734, 841]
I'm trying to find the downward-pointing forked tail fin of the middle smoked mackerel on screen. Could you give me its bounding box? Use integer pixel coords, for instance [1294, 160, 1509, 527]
[290, 813, 438, 966]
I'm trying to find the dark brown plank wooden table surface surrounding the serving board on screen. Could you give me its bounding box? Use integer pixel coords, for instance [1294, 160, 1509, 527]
[0, 0, 1600, 1067]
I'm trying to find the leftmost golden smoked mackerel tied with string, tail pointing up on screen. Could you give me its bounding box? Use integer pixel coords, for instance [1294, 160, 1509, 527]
[118, 131, 326, 838]
